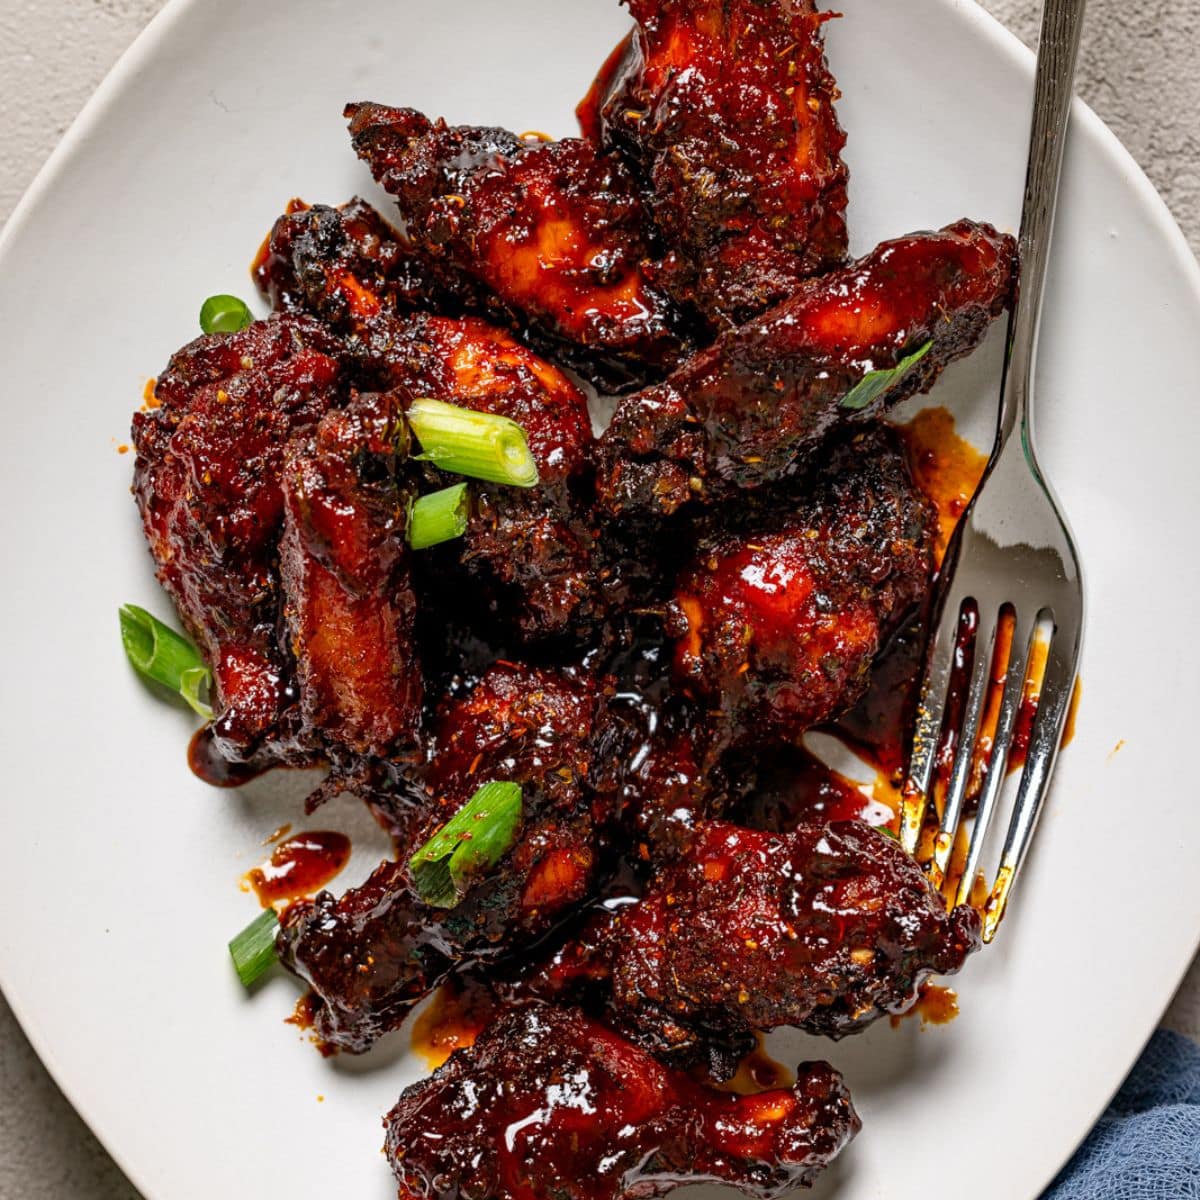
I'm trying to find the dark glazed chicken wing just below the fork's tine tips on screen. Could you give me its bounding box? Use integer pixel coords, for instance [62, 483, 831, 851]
[523, 821, 980, 1069]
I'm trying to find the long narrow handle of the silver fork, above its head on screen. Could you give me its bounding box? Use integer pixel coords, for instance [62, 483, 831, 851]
[996, 0, 1086, 453]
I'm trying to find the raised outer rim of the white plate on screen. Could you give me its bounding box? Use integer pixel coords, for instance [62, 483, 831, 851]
[0, 0, 1200, 1200]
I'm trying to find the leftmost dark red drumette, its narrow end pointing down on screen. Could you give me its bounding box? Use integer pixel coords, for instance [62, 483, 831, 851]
[133, 316, 346, 761]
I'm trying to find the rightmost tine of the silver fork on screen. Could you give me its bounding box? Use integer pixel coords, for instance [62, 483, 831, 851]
[983, 614, 1079, 942]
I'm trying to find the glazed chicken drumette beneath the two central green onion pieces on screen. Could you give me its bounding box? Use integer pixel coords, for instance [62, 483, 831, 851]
[257, 200, 647, 640]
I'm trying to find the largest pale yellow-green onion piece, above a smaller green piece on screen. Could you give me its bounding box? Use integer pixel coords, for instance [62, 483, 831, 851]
[406, 400, 538, 487]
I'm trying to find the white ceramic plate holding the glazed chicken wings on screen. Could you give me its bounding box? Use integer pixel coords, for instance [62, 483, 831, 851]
[0, 0, 1200, 1200]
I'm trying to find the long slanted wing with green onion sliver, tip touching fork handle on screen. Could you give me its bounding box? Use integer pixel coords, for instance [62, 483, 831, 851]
[598, 221, 1016, 516]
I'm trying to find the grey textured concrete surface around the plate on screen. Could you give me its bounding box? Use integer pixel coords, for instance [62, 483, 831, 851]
[0, 0, 1200, 1200]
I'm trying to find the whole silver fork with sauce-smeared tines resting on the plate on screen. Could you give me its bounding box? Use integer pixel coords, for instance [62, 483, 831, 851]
[900, 0, 1085, 942]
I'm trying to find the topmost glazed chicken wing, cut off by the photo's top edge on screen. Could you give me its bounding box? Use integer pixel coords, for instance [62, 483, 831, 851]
[581, 0, 847, 329]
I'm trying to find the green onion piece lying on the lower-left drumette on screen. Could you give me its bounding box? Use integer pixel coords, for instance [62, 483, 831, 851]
[408, 782, 521, 908]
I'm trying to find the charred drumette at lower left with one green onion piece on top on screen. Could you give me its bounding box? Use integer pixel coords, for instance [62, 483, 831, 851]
[278, 665, 599, 1052]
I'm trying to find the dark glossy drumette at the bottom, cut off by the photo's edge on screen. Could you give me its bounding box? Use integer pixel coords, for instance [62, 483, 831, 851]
[384, 1004, 859, 1200]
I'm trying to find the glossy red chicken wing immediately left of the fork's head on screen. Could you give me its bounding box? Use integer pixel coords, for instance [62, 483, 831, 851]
[674, 427, 936, 748]
